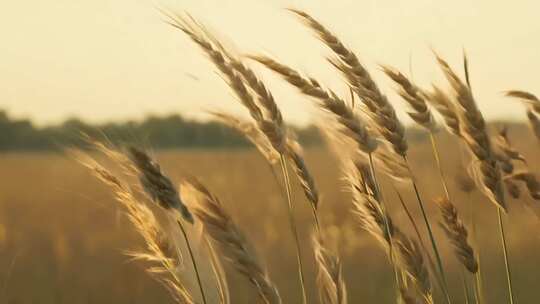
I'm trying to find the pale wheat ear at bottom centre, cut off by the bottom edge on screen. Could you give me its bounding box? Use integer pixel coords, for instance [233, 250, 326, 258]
[313, 236, 347, 304]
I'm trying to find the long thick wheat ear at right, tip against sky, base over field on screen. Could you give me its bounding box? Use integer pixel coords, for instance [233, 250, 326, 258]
[436, 54, 506, 211]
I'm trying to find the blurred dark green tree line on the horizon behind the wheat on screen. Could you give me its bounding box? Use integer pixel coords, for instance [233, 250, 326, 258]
[0, 110, 321, 151]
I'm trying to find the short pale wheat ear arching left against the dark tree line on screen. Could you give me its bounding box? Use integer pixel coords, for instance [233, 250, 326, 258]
[209, 111, 279, 165]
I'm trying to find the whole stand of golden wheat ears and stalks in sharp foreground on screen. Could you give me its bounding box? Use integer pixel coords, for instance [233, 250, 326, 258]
[6, 9, 540, 304]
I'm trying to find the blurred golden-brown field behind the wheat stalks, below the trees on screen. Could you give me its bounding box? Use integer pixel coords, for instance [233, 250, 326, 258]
[0, 128, 540, 304]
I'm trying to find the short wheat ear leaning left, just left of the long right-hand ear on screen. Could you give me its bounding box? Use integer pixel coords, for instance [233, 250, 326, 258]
[382, 66, 436, 132]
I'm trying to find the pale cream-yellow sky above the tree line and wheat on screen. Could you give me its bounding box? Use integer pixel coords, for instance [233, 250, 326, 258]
[0, 0, 540, 124]
